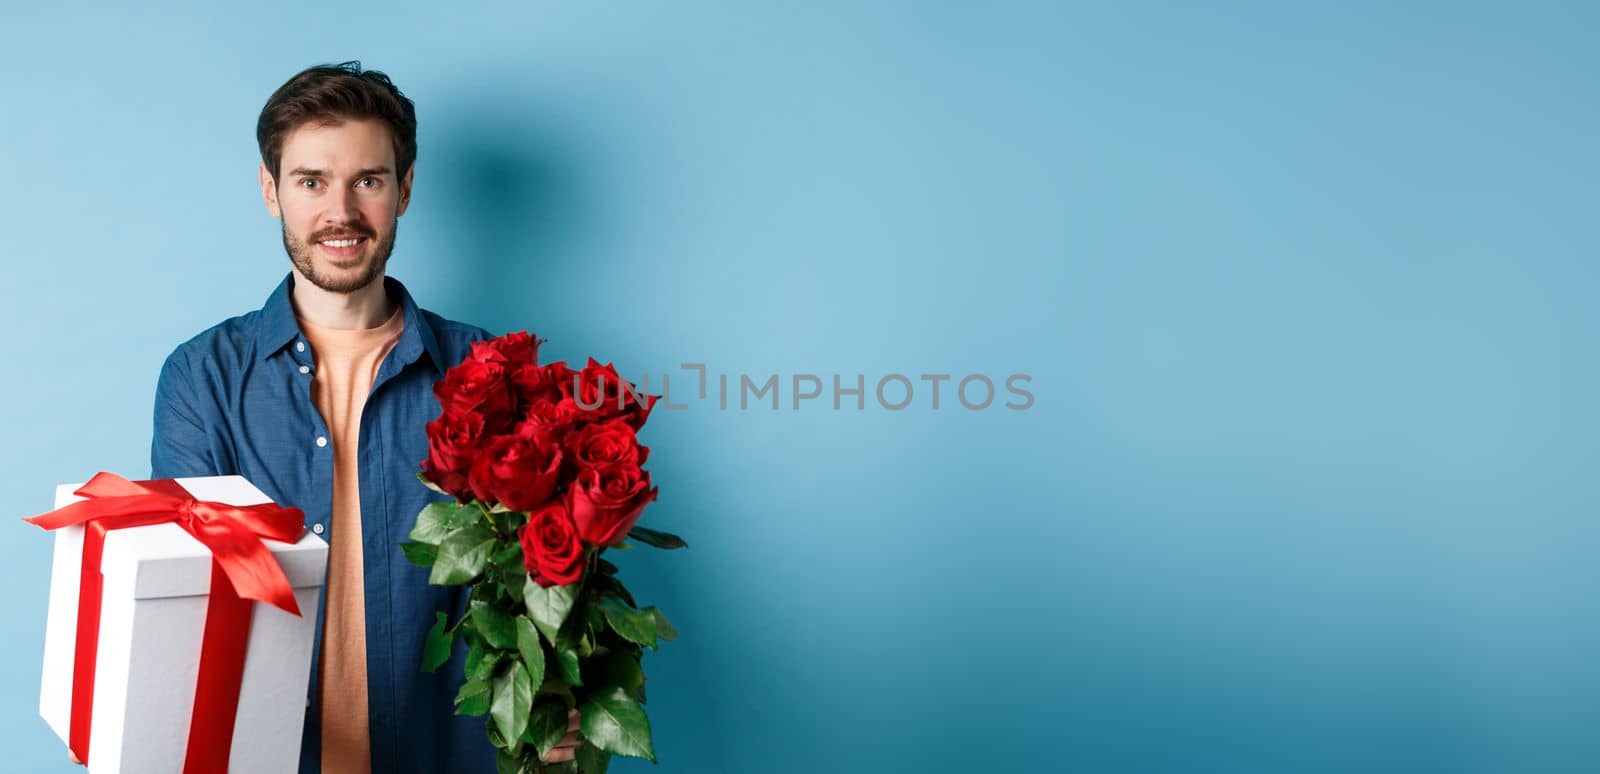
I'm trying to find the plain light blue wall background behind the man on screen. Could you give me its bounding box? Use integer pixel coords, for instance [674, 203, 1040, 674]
[0, 0, 1600, 772]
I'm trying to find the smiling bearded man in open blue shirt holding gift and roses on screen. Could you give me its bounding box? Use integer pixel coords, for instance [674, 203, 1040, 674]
[150, 62, 578, 774]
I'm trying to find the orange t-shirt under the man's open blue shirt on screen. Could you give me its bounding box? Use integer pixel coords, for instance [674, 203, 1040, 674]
[299, 305, 405, 774]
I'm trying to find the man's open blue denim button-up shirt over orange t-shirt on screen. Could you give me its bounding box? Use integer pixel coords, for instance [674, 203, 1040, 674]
[150, 273, 494, 774]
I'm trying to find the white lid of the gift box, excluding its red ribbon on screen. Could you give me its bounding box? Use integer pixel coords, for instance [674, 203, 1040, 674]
[56, 475, 328, 600]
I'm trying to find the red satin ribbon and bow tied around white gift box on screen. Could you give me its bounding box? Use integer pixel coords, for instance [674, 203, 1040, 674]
[24, 472, 306, 774]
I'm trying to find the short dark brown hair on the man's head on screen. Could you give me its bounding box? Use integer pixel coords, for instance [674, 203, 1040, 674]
[256, 61, 416, 181]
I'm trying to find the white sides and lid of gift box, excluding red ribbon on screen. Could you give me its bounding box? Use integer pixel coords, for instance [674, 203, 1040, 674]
[38, 475, 328, 774]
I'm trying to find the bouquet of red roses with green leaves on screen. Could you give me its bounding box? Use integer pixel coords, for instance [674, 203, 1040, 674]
[400, 333, 685, 774]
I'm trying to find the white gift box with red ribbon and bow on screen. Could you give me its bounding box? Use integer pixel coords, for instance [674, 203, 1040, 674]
[29, 473, 328, 774]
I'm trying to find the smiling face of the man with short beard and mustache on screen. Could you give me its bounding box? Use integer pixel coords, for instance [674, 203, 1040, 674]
[261, 120, 413, 293]
